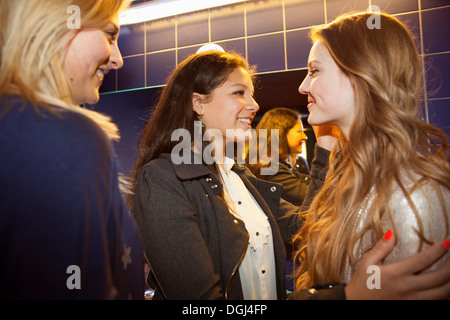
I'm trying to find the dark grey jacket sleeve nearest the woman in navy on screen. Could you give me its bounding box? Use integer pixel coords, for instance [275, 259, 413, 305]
[132, 159, 222, 300]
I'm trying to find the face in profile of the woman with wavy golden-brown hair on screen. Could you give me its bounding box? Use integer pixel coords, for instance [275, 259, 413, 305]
[299, 40, 355, 137]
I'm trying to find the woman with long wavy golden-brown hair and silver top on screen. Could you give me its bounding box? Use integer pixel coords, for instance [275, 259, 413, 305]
[297, 13, 450, 298]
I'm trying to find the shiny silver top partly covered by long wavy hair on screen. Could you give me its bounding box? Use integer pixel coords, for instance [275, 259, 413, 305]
[343, 174, 450, 283]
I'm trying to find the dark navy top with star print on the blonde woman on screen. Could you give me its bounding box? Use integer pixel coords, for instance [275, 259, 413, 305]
[0, 97, 144, 299]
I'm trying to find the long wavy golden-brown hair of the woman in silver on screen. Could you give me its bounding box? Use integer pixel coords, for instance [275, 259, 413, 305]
[295, 13, 450, 289]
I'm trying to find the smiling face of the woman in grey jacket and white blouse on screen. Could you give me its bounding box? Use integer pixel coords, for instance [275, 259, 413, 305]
[192, 68, 259, 146]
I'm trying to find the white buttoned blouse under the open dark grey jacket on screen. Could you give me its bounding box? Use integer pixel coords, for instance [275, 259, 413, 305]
[218, 158, 277, 300]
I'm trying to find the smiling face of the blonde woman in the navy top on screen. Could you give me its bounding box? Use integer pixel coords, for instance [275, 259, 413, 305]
[64, 19, 123, 104]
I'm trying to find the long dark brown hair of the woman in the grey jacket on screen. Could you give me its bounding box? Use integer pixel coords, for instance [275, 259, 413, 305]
[128, 51, 253, 204]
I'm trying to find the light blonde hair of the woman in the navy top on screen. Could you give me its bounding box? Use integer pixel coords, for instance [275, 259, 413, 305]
[0, 0, 127, 139]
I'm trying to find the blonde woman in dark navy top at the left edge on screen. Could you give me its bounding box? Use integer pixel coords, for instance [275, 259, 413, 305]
[0, 0, 143, 299]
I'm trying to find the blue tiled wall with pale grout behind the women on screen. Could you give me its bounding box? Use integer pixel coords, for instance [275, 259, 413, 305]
[97, 0, 450, 174]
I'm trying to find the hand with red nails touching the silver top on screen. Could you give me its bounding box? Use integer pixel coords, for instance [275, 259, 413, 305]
[345, 230, 450, 300]
